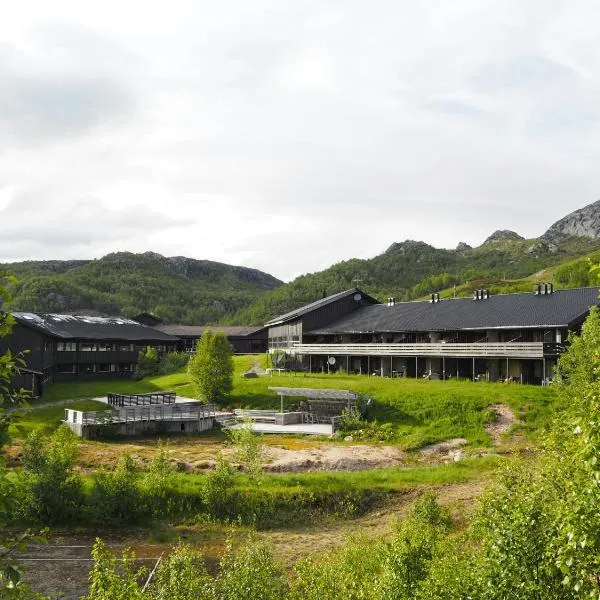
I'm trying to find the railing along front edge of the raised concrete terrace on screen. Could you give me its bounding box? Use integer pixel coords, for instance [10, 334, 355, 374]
[65, 402, 216, 425]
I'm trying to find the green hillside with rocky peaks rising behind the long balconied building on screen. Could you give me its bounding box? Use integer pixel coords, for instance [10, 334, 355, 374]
[228, 236, 600, 324]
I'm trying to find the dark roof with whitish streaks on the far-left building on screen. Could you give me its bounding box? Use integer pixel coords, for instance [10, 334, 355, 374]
[11, 312, 177, 342]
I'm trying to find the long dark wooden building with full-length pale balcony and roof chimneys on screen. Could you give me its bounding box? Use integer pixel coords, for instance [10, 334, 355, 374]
[266, 284, 600, 384]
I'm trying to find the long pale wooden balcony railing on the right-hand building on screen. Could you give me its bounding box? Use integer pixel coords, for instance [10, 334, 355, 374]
[282, 342, 548, 358]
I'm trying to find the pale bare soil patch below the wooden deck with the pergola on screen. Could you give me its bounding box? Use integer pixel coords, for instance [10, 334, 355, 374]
[263, 445, 406, 473]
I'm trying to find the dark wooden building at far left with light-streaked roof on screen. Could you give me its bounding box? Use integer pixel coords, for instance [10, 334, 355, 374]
[0, 313, 178, 382]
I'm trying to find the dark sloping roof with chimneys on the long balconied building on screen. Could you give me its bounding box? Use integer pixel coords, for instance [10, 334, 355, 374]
[306, 287, 600, 334]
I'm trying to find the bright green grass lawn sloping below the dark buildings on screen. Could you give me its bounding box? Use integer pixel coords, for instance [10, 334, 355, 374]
[23, 356, 556, 448]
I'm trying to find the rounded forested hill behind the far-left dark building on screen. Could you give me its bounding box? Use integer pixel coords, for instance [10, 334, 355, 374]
[0, 252, 282, 324]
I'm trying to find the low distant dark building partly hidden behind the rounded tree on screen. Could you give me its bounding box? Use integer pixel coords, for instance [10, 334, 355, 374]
[155, 325, 268, 354]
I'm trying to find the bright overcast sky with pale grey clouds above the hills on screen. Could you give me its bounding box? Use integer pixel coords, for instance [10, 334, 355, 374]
[0, 0, 600, 281]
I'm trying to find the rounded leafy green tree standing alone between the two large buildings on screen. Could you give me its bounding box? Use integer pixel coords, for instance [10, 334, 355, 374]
[188, 329, 233, 402]
